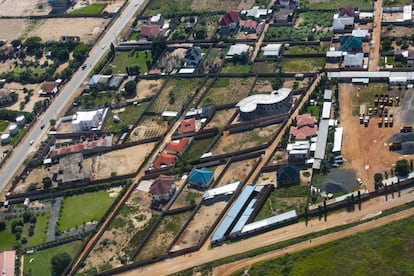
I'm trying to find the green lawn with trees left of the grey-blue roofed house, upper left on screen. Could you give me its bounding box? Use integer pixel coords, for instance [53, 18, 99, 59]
[104, 50, 152, 74]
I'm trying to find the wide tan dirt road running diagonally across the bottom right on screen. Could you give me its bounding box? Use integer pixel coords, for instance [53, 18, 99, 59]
[118, 182, 414, 275]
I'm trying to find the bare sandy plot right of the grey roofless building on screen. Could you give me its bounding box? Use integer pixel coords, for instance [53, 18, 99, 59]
[91, 143, 155, 179]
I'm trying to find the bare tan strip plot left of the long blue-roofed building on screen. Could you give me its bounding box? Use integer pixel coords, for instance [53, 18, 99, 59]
[172, 201, 227, 251]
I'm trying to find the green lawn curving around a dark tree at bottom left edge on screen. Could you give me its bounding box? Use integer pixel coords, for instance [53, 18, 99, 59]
[23, 241, 82, 276]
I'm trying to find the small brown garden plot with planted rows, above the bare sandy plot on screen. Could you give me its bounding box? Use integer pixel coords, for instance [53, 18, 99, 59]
[129, 116, 168, 142]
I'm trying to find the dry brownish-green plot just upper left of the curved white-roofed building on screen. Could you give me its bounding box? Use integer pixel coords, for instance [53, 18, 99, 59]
[201, 78, 254, 105]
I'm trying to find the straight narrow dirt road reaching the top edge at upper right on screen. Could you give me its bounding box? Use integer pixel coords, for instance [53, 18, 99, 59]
[368, 0, 382, 71]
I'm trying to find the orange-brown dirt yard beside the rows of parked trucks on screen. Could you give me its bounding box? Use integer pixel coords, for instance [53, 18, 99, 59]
[339, 84, 413, 191]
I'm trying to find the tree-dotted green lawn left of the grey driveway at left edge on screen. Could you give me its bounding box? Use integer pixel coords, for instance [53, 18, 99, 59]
[0, 212, 50, 251]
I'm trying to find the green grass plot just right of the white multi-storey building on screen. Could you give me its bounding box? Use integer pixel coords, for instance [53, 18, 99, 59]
[105, 102, 149, 132]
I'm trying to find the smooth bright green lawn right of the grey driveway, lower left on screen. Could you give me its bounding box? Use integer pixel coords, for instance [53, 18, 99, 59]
[59, 191, 114, 232]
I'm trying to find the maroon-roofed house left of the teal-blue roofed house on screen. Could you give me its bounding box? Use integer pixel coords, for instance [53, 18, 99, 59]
[149, 174, 176, 203]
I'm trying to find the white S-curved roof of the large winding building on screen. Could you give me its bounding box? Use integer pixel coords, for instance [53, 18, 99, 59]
[236, 88, 292, 112]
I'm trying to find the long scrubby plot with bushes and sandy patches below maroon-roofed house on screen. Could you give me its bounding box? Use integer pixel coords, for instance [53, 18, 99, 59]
[81, 190, 157, 274]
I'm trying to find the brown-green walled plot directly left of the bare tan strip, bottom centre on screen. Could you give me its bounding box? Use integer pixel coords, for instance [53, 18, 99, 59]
[135, 211, 191, 261]
